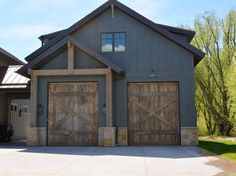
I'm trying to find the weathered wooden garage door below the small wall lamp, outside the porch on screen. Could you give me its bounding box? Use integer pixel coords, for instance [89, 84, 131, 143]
[128, 83, 179, 145]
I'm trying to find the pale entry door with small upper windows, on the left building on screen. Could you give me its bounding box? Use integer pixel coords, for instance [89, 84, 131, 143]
[9, 99, 30, 140]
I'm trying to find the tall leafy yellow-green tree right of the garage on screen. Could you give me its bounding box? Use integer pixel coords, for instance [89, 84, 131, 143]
[193, 10, 236, 135]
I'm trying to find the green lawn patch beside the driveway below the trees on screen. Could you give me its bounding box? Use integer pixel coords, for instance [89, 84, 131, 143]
[199, 139, 236, 161]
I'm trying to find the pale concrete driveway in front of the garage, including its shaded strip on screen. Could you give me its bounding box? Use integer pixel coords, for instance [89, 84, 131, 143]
[0, 147, 236, 176]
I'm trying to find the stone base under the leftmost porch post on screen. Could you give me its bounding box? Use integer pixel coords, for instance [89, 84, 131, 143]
[27, 127, 47, 146]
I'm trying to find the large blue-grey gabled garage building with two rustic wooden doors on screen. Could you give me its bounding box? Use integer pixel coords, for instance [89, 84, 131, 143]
[18, 0, 204, 146]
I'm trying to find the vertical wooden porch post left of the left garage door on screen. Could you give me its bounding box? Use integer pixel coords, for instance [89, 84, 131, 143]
[30, 76, 38, 127]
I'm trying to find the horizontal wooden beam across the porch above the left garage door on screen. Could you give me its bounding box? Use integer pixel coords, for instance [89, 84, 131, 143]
[31, 68, 110, 76]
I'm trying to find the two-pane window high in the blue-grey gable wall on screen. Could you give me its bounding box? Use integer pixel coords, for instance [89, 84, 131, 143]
[101, 33, 126, 52]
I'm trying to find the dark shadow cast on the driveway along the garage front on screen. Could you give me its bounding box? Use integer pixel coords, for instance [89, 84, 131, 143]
[0, 146, 214, 159]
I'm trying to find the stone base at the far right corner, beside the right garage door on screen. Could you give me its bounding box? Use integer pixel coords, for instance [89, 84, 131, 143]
[181, 127, 198, 145]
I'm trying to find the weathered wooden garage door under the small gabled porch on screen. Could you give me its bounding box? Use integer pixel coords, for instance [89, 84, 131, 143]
[48, 82, 98, 145]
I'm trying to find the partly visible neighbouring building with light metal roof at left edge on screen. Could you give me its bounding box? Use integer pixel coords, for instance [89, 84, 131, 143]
[0, 48, 30, 141]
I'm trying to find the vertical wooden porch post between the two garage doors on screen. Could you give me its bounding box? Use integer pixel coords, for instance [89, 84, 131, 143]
[106, 69, 112, 127]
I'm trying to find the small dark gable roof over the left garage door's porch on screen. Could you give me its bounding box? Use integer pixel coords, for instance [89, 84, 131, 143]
[18, 35, 124, 76]
